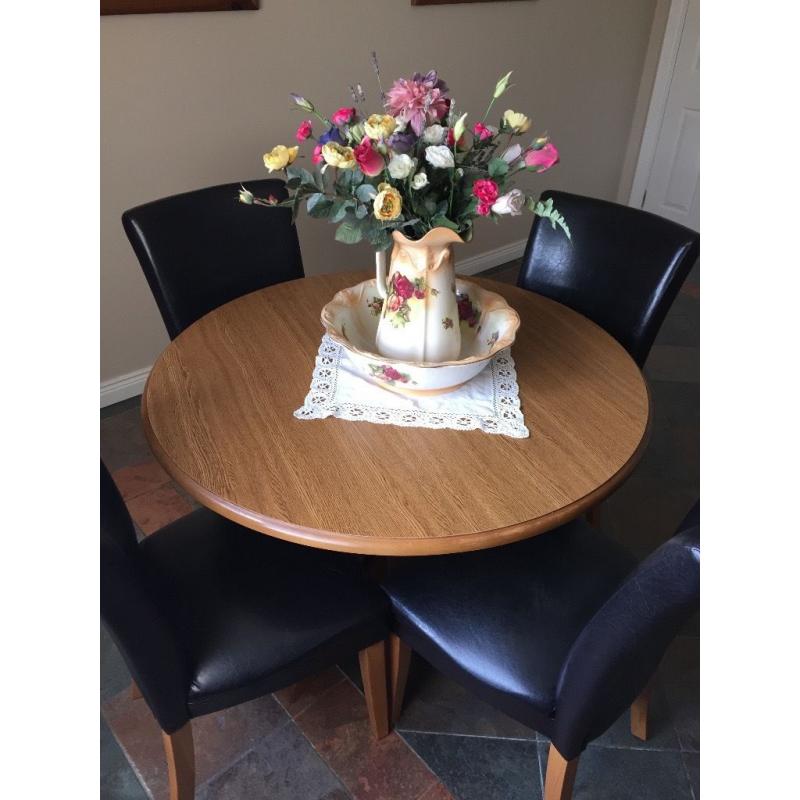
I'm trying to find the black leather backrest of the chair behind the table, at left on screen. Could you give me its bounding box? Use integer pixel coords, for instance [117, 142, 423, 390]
[122, 180, 303, 339]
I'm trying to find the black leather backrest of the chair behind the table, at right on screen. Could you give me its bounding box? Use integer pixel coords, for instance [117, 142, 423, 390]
[518, 191, 700, 366]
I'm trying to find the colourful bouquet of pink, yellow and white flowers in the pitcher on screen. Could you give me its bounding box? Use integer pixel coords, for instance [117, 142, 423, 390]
[239, 53, 569, 250]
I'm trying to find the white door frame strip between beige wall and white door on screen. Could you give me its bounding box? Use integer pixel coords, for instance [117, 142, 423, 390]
[628, 0, 689, 208]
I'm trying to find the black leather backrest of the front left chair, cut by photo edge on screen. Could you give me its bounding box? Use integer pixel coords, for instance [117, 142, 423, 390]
[100, 462, 189, 733]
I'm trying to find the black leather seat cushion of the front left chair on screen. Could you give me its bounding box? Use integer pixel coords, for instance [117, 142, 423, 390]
[140, 509, 388, 716]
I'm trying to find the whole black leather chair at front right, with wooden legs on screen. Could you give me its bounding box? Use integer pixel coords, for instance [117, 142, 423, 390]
[382, 503, 700, 800]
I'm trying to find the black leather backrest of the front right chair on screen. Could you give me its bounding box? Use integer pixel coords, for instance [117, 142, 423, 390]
[553, 503, 700, 759]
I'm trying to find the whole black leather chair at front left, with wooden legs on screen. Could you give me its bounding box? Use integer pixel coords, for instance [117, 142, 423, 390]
[100, 462, 389, 800]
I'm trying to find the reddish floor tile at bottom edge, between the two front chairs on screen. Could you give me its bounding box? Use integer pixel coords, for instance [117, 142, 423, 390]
[295, 681, 437, 800]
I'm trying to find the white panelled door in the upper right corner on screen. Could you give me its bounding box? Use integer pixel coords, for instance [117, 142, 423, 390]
[641, 0, 700, 231]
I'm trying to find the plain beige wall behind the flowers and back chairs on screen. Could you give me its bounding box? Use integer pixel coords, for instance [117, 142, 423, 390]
[101, 0, 656, 380]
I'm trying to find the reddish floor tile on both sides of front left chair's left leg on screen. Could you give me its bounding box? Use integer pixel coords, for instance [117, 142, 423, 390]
[102, 688, 289, 800]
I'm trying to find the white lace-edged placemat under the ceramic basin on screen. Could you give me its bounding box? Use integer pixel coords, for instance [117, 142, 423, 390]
[294, 335, 530, 439]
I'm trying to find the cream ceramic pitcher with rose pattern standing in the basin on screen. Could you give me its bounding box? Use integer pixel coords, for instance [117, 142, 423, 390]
[375, 228, 464, 363]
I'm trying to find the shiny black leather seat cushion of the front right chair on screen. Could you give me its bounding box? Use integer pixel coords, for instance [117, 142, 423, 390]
[383, 520, 635, 732]
